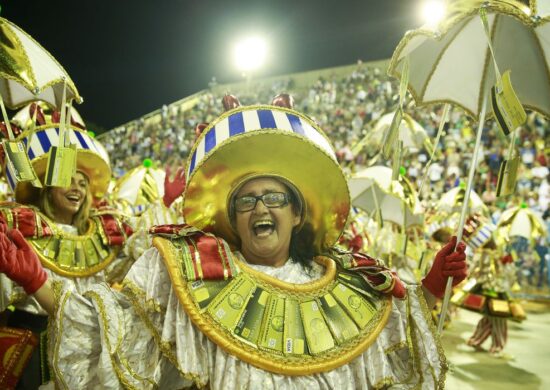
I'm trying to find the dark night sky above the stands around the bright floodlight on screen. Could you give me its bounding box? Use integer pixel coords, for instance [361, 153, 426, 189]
[0, 0, 421, 129]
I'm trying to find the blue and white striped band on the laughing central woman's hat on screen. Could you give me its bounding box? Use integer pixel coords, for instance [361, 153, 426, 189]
[187, 106, 336, 180]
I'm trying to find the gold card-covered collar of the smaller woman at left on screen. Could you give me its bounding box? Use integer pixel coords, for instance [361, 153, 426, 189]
[27, 213, 120, 277]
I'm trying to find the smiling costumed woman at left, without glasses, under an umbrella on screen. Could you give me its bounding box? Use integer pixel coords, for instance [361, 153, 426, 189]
[0, 103, 135, 389]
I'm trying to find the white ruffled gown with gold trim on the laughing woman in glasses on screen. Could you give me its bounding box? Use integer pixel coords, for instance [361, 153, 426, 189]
[49, 248, 446, 390]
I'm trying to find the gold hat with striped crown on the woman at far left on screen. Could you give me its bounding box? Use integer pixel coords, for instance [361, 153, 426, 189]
[5, 102, 111, 204]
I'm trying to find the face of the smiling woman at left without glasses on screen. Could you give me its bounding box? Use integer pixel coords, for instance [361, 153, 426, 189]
[50, 172, 88, 225]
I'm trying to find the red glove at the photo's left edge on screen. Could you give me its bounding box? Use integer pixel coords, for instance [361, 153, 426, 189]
[0, 228, 48, 295]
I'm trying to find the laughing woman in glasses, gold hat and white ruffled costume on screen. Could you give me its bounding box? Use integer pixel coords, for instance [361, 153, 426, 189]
[0, 96, 465, 389]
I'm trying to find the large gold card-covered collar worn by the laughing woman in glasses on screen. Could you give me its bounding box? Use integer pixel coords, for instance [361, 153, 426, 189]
[153, 237, 391, 375]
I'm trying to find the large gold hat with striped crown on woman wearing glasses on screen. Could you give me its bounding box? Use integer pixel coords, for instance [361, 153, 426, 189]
[183, 106, 350, 253]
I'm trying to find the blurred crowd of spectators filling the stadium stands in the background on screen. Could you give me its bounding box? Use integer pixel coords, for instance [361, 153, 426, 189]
[101, 62, 550, 286]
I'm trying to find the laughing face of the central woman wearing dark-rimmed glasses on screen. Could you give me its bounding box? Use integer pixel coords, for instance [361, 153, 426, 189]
[234, 177, 300, 267]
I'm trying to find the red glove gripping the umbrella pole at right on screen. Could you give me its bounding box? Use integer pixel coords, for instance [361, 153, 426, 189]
[422, 236, 468, 298]
